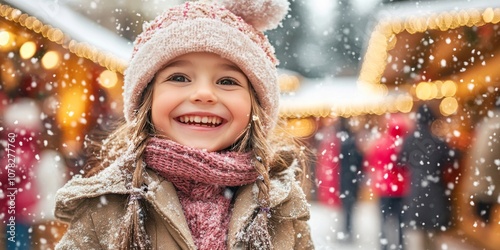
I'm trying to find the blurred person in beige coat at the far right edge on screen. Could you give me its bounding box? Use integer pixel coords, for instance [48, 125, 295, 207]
[460, 97, 500, 247]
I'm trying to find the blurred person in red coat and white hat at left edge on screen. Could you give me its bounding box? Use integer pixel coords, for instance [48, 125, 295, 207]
[0, 98, 41, 249]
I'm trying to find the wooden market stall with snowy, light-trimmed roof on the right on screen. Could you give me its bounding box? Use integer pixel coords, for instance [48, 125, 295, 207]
[359, 1, 500, 249]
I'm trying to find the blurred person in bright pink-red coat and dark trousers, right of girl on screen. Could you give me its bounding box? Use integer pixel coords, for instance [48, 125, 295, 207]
[366, 115, 409, 250]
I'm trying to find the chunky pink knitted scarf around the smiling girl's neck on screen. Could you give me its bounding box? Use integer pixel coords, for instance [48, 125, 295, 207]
[144, 137, 259, 250]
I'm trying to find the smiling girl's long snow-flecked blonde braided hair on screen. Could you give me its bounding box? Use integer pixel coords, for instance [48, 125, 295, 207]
[86, 83, 306, 249]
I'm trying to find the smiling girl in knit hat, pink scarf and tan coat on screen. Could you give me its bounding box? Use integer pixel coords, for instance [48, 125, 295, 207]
[55, 0, 313, 249]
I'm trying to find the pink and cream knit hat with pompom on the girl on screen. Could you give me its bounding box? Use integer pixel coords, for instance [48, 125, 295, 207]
[124, 0, 289, 130]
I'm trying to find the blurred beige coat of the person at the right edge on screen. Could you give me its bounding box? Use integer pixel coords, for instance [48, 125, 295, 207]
[465, 109, 500, 203]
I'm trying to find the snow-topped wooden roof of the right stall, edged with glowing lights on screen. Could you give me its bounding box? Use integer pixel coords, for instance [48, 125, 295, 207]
[359, 1, 500, 103]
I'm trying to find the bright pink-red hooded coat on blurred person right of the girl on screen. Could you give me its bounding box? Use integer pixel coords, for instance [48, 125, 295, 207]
[366, 118, 410, 197]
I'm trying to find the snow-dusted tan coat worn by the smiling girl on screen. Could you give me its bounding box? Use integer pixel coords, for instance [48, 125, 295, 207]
[55, 160, 314, 250]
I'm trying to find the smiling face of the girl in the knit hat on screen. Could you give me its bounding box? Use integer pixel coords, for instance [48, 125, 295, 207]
[151, 53, 251, 151]
